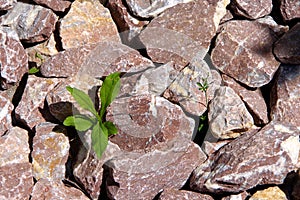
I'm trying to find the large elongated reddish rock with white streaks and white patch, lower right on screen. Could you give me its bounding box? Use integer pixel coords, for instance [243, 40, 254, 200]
[190, 121, 300, 193]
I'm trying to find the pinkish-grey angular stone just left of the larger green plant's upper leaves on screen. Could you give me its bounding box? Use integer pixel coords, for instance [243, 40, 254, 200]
[15, 76, 61, 129]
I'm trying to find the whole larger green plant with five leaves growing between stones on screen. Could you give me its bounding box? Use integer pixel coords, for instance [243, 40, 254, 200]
[63, 72, 121, 158]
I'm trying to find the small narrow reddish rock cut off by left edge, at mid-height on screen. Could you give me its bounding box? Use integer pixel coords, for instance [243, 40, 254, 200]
[0, 91, 14, 135]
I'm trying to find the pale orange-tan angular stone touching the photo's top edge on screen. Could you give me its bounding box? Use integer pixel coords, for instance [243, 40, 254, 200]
[59, 0, 121, 49]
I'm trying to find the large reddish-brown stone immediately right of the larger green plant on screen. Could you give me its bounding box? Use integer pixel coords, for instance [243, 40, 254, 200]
[106, 94, 194, 152]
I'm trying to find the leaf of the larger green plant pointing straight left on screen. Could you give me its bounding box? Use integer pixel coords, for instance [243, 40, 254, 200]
[64, 115, 94, 131]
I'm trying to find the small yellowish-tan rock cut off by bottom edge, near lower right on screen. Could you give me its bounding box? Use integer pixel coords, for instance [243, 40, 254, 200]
[249, 186, 288, 200]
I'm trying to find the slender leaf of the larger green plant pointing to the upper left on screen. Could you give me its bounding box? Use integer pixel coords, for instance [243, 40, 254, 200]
[66, 86, 98, 116]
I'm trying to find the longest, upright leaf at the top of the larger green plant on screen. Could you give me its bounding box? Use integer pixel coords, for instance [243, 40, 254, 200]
[100, 72, 121, 119]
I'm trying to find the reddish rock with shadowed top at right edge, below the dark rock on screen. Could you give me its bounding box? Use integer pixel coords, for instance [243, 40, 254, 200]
[271, 65, 300, 127]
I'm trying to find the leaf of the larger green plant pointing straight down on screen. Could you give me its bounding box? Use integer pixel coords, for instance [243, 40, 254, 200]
[92, 122, 108, 159]
